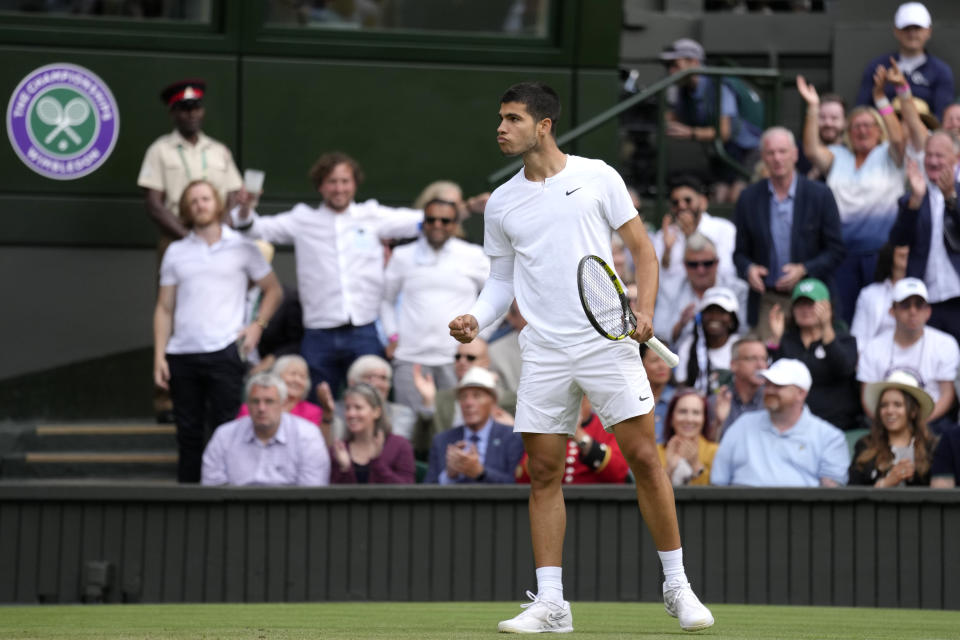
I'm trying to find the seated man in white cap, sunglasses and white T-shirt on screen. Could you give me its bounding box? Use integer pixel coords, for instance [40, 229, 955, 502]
[857, 278, 960, 435]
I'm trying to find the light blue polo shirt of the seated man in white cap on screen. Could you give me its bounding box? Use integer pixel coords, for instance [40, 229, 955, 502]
[710, 406, 850, 487]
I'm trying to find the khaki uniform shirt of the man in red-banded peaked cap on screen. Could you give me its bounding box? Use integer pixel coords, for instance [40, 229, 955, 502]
[137, 130, 243, 217]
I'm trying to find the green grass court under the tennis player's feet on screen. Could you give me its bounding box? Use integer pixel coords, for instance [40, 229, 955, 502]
[0, 600, 960, 640]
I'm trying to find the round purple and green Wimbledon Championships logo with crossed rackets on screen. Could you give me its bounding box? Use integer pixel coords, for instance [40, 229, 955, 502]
[7, 63, 120, 180]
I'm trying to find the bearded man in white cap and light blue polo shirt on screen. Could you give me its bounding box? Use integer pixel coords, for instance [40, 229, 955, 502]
[710, 358, 850, 487]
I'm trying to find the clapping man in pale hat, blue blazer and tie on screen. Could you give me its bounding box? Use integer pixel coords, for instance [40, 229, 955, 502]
[424, 367, 523, 484]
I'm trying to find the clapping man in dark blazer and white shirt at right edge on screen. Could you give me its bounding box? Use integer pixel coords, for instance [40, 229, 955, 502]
[890, 131, 960, 342]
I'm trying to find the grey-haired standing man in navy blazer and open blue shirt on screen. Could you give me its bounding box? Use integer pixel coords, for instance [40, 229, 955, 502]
[733, 127, 840, 332]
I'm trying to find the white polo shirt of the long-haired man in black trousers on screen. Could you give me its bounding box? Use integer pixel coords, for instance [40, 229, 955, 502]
[160, 225, 270, 353]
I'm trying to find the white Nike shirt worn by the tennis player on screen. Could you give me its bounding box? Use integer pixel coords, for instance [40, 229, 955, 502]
[483, 155, 637, 347]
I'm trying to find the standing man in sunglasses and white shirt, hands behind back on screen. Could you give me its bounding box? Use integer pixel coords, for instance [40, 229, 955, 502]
[380, 198, 490, 420]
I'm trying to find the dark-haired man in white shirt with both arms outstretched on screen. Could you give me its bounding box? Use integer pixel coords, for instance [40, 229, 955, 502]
[232, 151, 423, 396]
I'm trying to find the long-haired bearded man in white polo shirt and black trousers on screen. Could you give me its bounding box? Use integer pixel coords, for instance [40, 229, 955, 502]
[153, 180, 283, 482]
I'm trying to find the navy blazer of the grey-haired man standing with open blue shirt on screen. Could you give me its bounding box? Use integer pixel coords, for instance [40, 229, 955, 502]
[733, 175, 846, 326]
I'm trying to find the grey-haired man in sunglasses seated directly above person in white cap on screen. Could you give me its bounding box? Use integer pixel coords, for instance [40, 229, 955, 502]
[653, 231, 747, 343]
